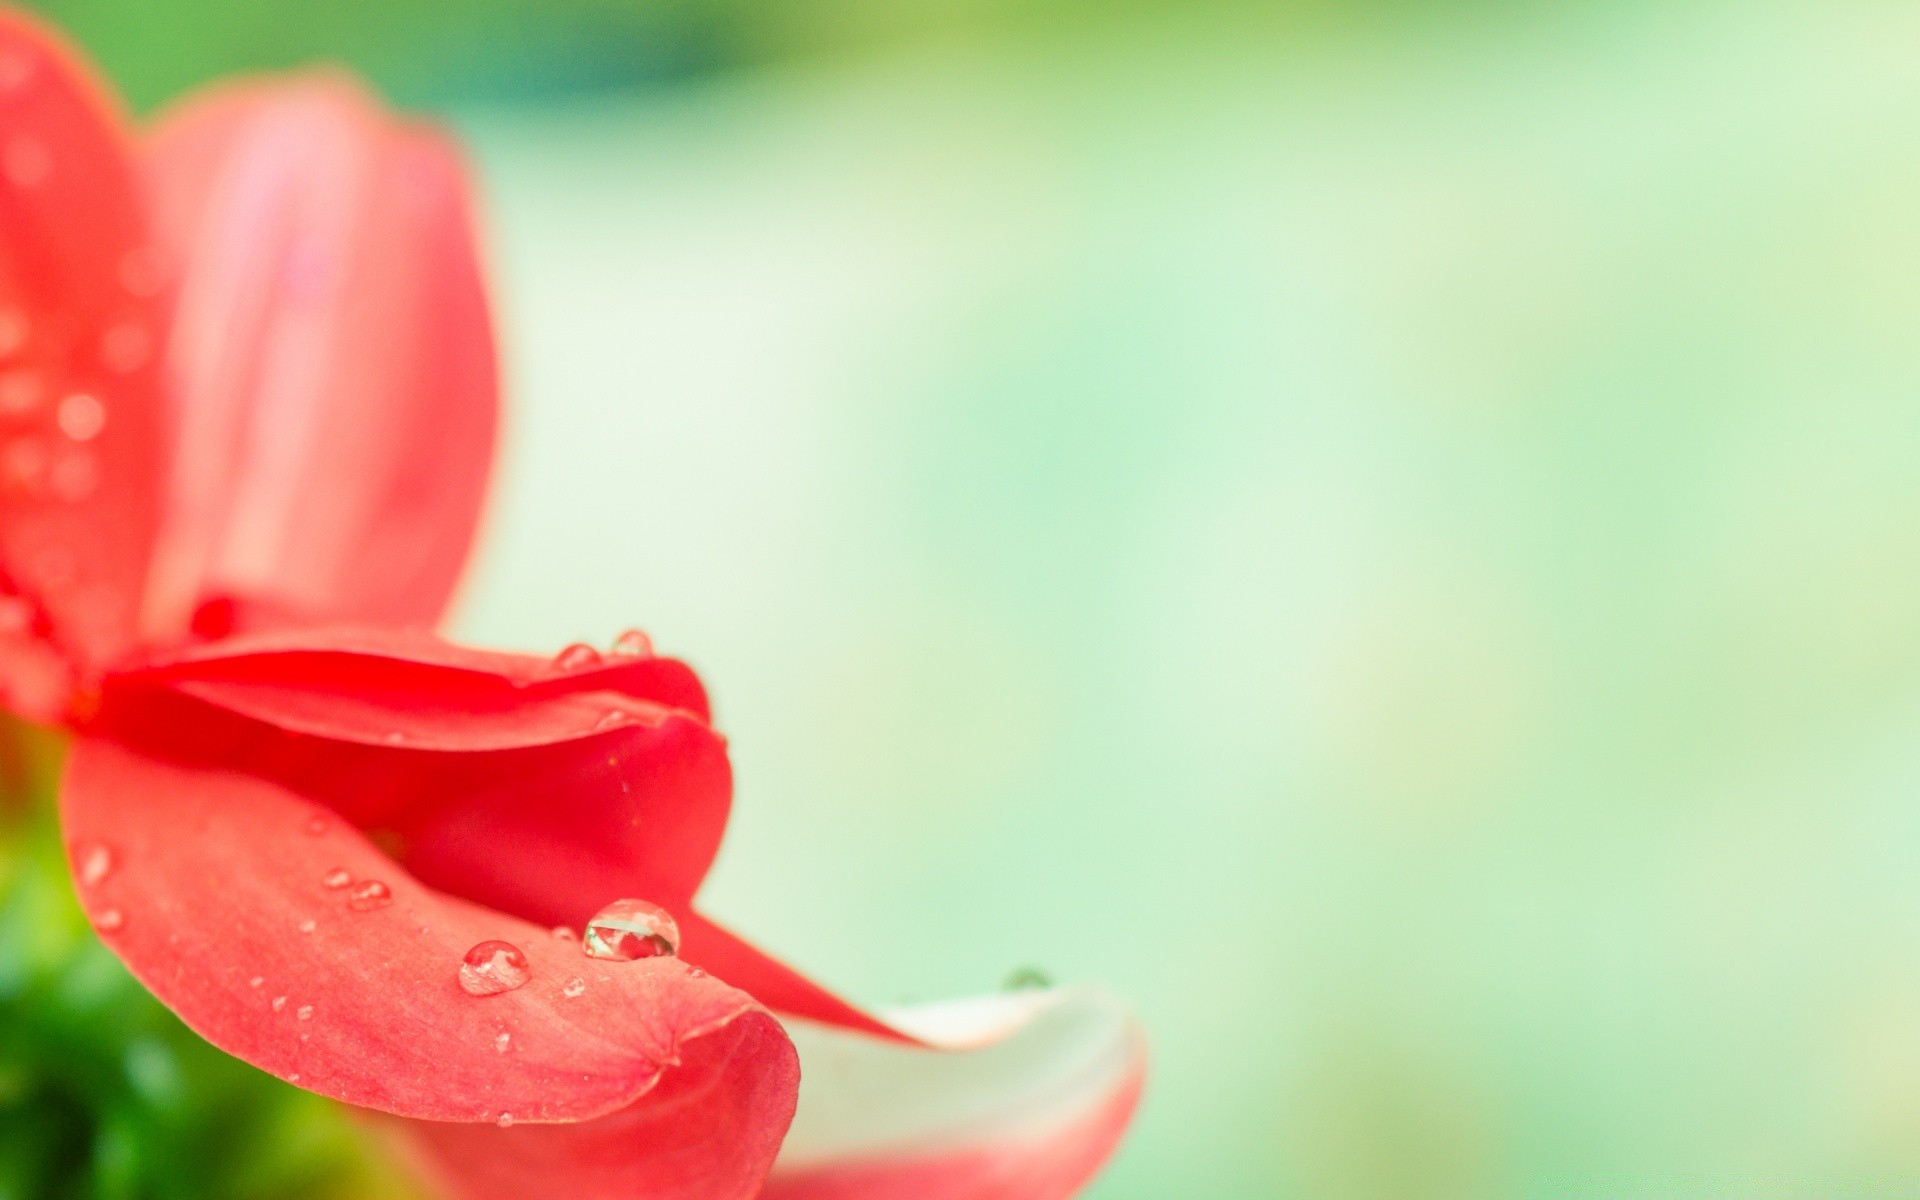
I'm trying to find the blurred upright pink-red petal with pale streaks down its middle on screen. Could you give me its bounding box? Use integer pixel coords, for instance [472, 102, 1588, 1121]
[146, 75, 497, 637]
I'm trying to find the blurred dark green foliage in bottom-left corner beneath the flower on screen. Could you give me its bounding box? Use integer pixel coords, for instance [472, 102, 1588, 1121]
[0, 728, 420, 1200]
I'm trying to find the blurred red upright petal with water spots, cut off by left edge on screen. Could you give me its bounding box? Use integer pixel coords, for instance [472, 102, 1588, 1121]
[0, 10, 161, 718]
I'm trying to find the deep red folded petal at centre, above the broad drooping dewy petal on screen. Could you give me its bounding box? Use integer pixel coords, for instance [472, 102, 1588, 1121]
[94, 632, 732, 913]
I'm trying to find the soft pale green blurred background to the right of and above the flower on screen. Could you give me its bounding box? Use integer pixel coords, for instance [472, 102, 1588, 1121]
[26, 0, 1920, 1200]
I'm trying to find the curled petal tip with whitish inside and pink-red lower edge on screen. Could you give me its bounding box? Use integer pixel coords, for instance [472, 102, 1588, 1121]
[764, 987, 1146, 1200]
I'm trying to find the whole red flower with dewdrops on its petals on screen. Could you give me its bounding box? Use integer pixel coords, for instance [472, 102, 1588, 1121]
[0, 13, 1142, 1200]
